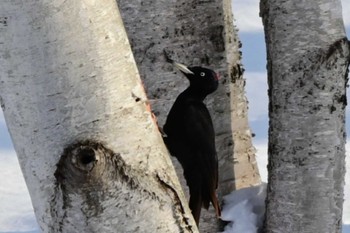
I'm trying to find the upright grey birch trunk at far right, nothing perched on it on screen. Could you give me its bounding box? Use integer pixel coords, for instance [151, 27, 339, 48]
[261, 0, 349, 233]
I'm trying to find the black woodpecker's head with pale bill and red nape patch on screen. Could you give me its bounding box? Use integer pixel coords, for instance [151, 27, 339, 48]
[173, 62, 219, 95]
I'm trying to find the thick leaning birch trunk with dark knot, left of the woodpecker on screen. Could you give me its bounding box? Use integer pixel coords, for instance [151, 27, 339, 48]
[0, 0, 198, 233]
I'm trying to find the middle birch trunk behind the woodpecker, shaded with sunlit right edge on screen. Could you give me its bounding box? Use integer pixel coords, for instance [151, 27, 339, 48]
[117, 0, 260, 232]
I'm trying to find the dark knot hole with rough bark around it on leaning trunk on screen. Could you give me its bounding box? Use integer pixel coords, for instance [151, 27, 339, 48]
[50, 140, 124, 222]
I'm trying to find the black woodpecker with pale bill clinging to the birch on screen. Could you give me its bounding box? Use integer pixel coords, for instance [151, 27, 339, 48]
[163, 53, 221, 226]
